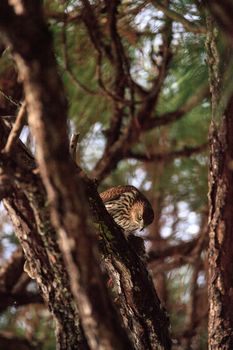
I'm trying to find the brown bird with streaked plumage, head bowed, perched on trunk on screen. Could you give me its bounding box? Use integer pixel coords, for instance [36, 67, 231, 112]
[100, 186, 154, 236]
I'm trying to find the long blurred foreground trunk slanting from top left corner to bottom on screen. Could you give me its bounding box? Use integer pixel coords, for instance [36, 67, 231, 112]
[0, 1, 131, 349]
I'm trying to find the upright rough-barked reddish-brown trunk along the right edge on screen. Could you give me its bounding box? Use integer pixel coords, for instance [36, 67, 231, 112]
[207, 18, 233, 350]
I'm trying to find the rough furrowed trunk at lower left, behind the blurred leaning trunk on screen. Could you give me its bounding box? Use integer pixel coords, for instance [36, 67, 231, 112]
[0, 120, 89, 350]
